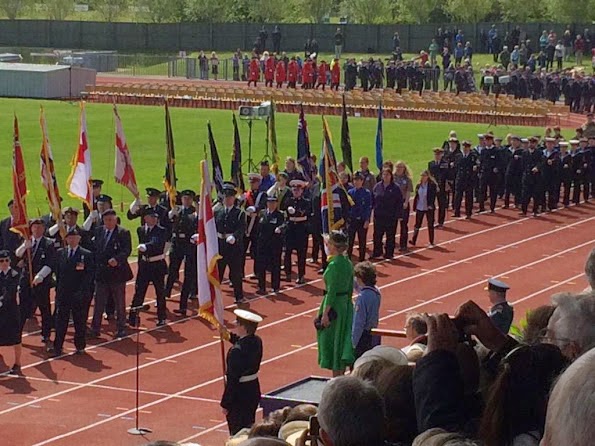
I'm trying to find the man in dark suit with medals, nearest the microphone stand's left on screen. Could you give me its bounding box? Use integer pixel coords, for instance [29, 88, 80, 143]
[54, 229, 95, 357]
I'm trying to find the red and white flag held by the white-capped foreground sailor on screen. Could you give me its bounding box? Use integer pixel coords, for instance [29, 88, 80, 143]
[196, 160, 224, 327]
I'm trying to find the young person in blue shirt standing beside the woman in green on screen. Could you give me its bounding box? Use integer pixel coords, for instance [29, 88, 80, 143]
[351, 262, 380, 359]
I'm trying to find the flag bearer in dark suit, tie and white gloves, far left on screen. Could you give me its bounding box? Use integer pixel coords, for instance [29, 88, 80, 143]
[15, 218, 56, 344]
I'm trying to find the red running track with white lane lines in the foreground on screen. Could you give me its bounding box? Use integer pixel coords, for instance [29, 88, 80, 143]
[0, 204, 595, 445]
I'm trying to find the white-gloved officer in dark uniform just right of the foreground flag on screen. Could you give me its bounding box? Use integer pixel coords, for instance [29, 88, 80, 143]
[215, 182, 246, 304]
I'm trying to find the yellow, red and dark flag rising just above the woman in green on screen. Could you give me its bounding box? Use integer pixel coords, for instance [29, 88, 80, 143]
[320, 116, 345, 234]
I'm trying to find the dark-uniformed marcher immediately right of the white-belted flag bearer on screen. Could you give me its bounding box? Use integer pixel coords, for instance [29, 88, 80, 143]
[164, 189, 197, 316]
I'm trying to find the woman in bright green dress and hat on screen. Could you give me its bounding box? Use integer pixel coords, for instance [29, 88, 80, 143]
[317, 231, 354, 376]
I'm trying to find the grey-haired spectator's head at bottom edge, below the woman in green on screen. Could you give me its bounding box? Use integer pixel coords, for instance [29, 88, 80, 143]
[318, 376, 384, 446]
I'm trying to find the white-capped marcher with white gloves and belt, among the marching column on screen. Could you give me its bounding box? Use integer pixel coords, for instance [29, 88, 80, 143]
[285, 180, 312, 285]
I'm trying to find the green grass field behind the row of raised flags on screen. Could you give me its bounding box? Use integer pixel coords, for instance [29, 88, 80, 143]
[0, 99, 556, 230]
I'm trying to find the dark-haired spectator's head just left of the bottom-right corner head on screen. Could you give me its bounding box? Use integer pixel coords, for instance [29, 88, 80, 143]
[479, 344, 567, 446]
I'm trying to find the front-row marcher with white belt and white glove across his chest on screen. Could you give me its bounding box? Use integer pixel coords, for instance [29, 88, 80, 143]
[128, 209, 167, 327]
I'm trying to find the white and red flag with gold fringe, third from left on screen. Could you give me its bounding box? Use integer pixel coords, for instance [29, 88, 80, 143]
[68, 102, 93, 209]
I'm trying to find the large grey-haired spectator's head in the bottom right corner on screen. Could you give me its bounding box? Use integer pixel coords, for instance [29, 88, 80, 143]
[541, 349, 595, 446]
